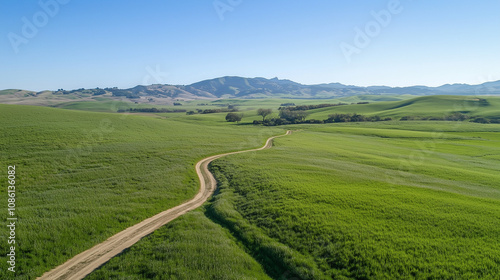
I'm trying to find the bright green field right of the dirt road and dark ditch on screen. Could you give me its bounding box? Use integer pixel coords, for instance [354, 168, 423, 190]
[205, 122, 500, 279]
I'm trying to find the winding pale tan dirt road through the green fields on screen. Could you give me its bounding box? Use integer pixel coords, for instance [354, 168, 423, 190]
[37, 130, 291, 280]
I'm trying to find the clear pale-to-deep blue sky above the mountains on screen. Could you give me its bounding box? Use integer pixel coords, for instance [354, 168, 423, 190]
[0, 0, 500, 90]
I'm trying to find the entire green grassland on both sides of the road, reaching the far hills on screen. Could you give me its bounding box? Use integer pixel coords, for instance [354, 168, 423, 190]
[0, 96, 500, 279]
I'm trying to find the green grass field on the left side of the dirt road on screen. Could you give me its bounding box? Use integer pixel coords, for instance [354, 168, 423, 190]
[0, 105, 283, 279]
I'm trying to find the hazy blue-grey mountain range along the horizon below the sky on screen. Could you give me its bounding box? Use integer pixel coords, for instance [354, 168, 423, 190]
[0, 77, 500, 101]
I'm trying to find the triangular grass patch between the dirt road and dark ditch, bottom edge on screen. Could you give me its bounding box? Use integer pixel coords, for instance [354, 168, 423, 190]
[85, 210, 270, 280]
